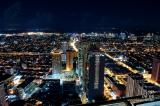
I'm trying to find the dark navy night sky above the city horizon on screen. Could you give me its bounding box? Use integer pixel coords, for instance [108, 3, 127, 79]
[0, 0, 160, 31]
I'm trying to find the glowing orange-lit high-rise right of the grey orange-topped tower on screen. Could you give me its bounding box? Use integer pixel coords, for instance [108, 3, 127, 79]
[66, 50, 77, 71]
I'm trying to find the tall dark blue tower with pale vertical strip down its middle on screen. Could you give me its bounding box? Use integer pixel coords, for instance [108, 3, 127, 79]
[85, 51, 105, 101]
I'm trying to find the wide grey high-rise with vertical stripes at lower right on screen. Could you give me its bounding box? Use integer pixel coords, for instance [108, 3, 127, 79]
[126, 74, 160, 97]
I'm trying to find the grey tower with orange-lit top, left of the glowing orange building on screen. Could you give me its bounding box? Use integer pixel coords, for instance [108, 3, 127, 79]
[52, 50, 62, 74]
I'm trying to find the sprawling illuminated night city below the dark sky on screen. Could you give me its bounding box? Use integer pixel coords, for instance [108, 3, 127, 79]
[0, 32, 160, 106]
